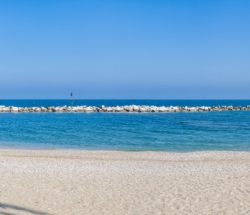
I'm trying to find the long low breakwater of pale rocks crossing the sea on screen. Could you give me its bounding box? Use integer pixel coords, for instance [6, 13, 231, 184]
[0, 105, 250, 113]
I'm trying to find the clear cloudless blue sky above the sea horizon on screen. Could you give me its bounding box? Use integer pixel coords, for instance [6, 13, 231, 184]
[0, 0, 250, 99]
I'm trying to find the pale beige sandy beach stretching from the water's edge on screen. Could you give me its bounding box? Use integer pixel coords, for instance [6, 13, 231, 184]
[0, 150, 250, 215]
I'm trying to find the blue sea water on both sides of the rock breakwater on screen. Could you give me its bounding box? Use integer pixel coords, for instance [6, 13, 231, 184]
[0, 100, 250, 152]
